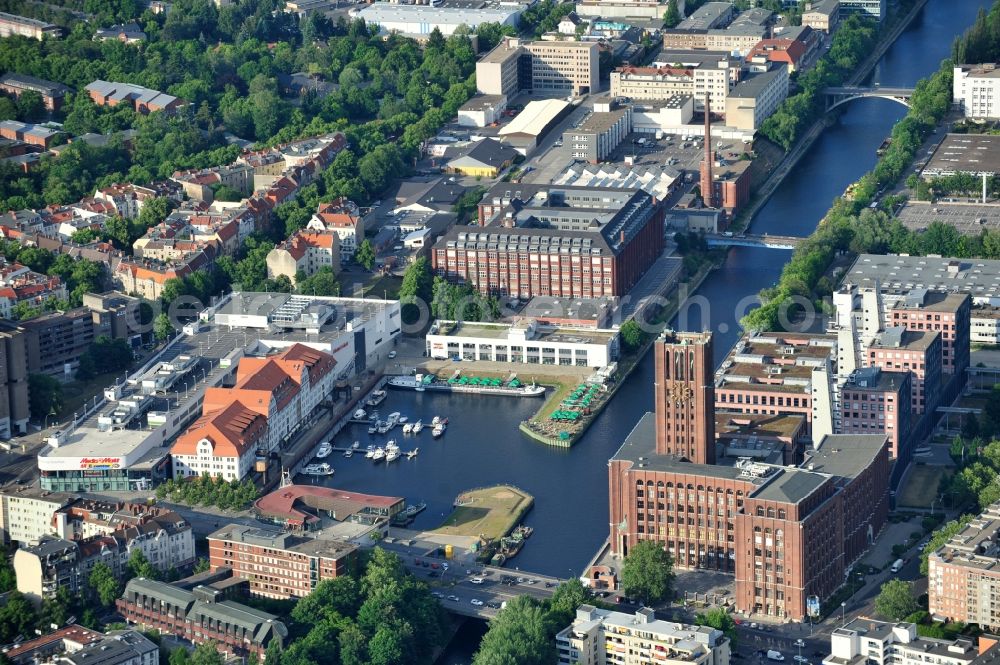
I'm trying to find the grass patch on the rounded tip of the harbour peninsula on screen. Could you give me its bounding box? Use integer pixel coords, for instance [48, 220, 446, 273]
[434, 485, 535, 539]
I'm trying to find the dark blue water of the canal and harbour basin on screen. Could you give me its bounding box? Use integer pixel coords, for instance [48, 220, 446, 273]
[318, 0, 990, 652]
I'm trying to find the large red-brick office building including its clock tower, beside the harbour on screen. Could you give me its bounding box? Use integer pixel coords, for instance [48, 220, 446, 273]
[608, 333, 889, 620]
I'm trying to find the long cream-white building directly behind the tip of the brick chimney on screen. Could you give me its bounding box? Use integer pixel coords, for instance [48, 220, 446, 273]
[611, 51, 740, 115]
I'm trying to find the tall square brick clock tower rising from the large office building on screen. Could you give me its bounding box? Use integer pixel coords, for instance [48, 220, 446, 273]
[654, 331, 715, 464]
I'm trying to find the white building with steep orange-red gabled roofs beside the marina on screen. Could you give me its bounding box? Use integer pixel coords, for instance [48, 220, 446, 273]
[170, 343, 336, 480]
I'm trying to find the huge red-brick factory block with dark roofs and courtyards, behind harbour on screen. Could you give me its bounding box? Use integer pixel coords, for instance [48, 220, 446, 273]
[431, 183, 664, 300]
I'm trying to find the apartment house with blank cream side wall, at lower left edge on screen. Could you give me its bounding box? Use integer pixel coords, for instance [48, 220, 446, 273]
[14, 538, 85, 606]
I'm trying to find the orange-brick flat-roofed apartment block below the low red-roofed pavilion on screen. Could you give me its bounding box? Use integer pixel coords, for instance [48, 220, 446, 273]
[208, 524, 358, 599]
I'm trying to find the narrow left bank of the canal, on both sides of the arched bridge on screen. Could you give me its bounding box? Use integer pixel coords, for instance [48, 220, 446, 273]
[730, 0, 928, 232]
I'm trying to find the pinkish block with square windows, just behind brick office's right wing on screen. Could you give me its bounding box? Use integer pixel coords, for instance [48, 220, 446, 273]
[835, 367, 913, 463]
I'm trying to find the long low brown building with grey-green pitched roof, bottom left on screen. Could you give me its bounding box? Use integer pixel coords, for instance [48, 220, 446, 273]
[116, 577, 288, 658]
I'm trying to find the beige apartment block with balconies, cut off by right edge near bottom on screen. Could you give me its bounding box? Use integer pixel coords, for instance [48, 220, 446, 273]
[927, 502, 1000, 630]
